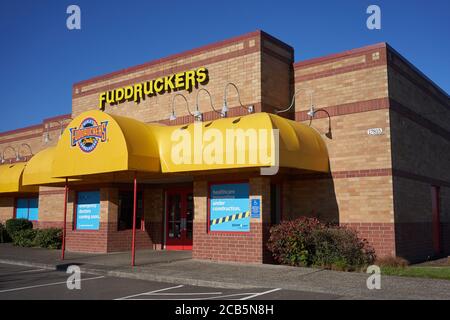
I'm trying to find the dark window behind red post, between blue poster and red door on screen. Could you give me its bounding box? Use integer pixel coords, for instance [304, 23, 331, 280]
[117, 191, 144, 230]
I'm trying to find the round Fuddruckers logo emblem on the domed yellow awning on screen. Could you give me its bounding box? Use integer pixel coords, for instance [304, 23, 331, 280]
[69, 118, 108, 153]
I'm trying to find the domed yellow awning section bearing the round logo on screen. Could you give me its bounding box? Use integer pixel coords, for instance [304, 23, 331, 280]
[52, 110, 160, 178]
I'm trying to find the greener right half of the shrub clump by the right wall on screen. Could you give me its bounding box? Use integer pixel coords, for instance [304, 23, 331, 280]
[312, 227, 375, 271]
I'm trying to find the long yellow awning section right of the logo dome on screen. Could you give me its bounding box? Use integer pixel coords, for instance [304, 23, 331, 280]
[156, 112, 329, 173]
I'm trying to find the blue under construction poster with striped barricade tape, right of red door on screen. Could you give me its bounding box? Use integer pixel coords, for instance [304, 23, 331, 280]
[210, 183, 250, 232]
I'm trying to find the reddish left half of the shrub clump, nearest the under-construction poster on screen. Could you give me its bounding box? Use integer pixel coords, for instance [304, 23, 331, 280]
[267, 217, 324, 266]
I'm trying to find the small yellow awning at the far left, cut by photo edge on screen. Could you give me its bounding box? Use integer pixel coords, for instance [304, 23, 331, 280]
[0, 162, 39, 193]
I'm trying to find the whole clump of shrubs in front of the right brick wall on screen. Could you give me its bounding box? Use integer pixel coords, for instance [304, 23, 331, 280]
[267, 217, 375, 271]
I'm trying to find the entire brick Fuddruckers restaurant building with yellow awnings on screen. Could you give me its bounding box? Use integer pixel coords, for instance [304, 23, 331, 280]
[0, 31, 450, 263]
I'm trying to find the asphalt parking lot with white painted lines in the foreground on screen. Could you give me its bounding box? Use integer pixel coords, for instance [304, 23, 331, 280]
[0, 264, 339, 300]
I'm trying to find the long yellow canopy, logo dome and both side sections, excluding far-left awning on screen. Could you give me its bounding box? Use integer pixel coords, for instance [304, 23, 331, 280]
[24, 110, 329, 181]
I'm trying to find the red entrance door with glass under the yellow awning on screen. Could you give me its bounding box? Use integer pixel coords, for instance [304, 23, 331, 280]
[166, 189, 194, 250]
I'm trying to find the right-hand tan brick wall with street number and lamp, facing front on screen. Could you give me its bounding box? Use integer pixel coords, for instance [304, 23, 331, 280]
[292, 44, 395, 256]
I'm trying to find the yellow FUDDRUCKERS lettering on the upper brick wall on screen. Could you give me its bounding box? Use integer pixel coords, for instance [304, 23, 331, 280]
[98, 67, 208, 110]
